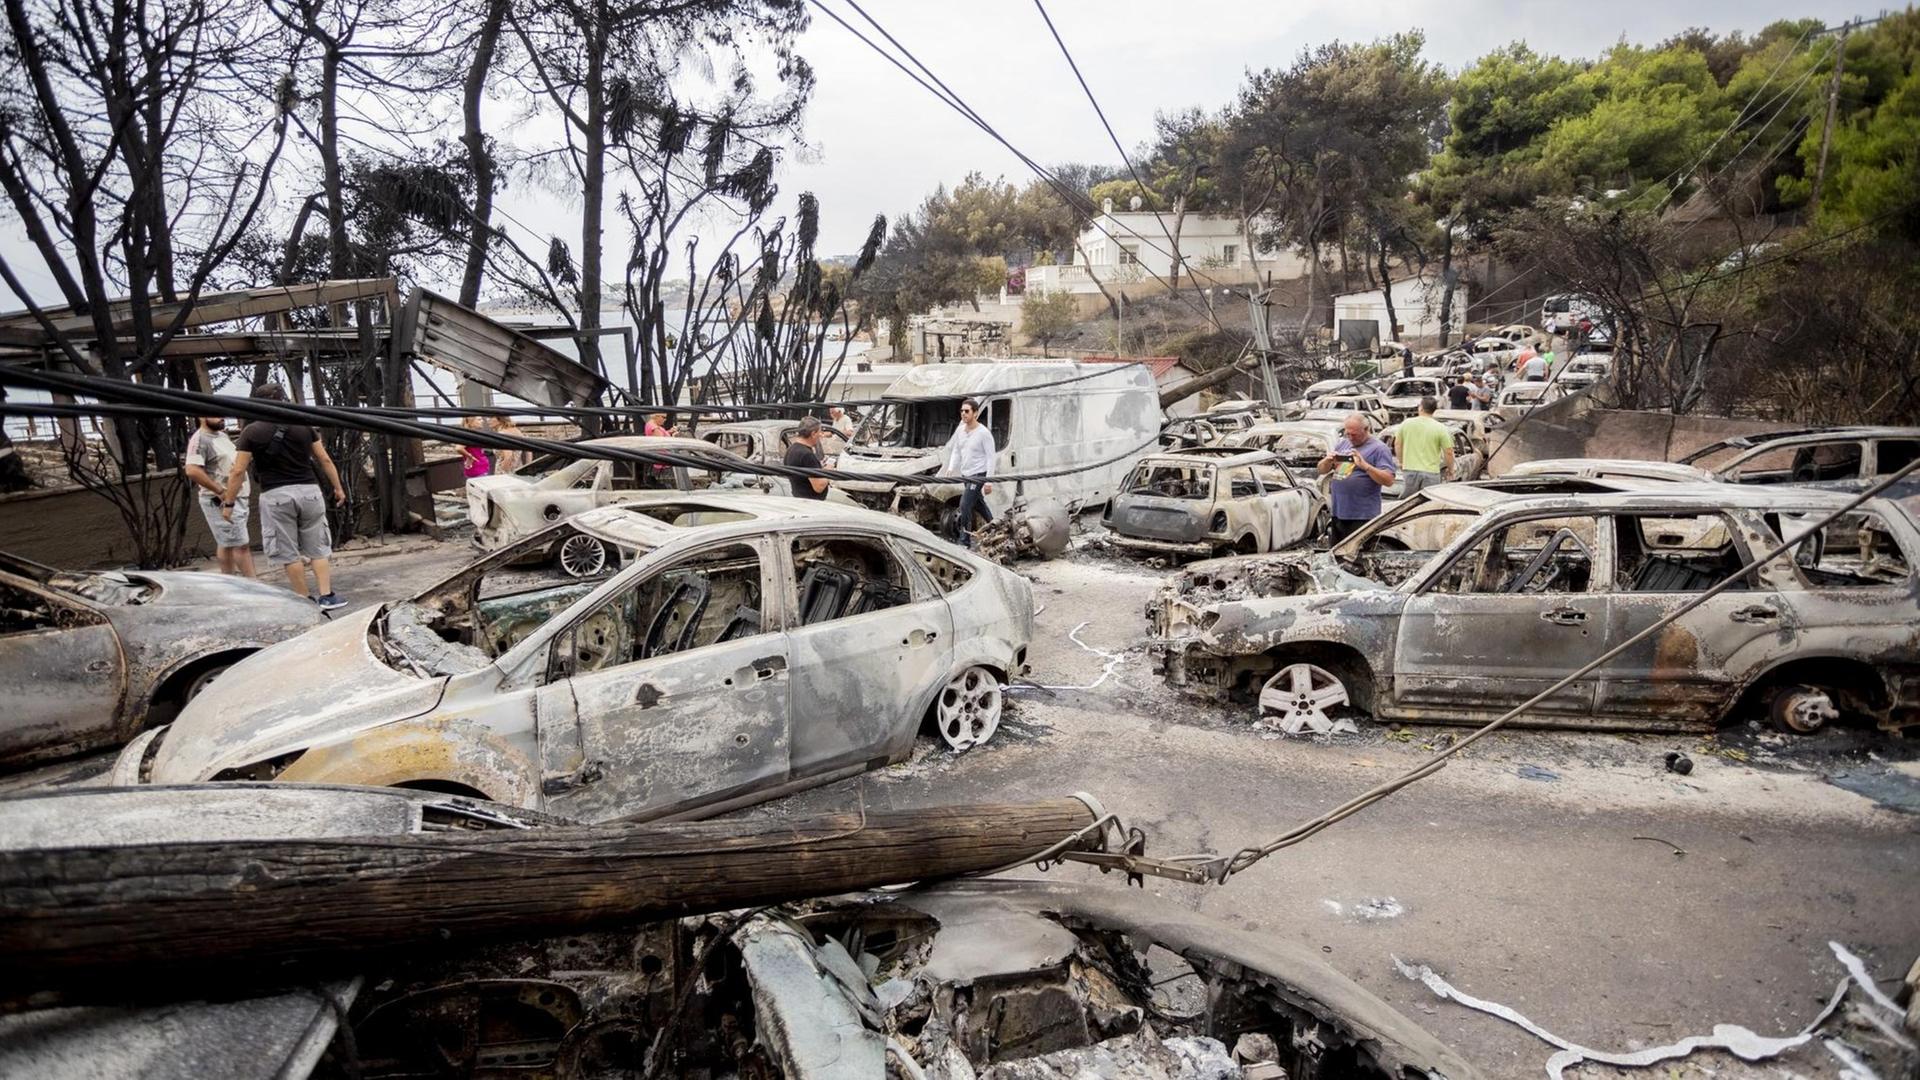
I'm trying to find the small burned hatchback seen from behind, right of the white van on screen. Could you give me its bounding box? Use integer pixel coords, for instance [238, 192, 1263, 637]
[1104, 446, 1327, 555]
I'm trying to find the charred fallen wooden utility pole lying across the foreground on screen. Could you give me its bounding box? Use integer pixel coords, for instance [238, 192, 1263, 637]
[0, 798, 1096, 1001]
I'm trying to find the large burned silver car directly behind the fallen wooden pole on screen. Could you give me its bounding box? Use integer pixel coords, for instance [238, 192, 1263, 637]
[113, 492, 1033, 821]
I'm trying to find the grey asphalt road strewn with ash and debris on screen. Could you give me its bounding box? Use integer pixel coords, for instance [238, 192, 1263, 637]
[52, 526, 1920, 1078]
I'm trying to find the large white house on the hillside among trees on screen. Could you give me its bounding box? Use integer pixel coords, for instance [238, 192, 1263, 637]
[1027, 200, 1306, 292]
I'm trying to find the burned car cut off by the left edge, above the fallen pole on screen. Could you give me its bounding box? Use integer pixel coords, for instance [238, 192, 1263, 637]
[0, 553, 326, 767]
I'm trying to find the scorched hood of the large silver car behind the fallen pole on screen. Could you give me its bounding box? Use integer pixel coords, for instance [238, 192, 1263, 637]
[150, 607, 445, 784]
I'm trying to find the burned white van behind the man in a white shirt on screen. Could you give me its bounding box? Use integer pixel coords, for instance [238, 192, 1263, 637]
[835, 359, 1165, 534]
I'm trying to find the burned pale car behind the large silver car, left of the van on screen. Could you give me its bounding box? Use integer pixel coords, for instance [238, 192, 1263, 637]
[467, 434, 771, 552]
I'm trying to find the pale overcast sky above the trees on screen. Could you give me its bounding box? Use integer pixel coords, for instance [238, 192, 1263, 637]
[0, 0, 1862, 307]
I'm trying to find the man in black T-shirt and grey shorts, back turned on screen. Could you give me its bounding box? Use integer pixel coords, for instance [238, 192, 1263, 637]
[221, 382, 348, 609]
